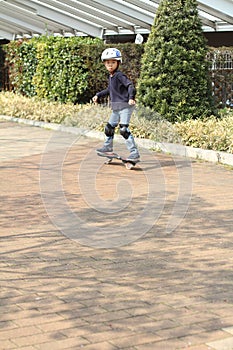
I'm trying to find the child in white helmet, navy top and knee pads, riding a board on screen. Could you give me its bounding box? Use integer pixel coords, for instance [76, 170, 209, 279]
[93, 48, 140, 161]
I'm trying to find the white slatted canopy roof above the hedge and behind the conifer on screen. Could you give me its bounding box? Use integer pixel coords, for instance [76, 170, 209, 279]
[0, 0, 233, 40]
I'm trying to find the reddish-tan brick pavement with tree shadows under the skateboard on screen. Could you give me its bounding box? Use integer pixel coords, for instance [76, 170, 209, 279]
[0, 122, 233, 350]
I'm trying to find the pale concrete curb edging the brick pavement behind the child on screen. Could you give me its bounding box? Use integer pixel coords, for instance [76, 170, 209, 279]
[0, 115, 233, 166]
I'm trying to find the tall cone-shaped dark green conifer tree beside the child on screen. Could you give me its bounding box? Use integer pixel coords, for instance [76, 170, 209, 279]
[138, 0, 214, 122]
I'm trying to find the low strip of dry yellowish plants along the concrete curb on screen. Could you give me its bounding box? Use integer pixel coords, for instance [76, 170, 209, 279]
[0, 92, 233, 153]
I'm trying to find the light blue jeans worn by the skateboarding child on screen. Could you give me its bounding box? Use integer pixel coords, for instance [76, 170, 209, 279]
[104, 106, 139, 157]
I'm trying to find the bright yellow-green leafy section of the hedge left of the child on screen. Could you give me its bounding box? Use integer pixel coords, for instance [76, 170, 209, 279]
[33, 38, 88, 103]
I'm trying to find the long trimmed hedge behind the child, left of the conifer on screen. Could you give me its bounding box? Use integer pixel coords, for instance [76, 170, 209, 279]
[2, 36, 143, 104]
